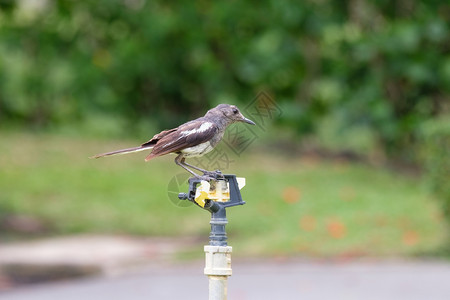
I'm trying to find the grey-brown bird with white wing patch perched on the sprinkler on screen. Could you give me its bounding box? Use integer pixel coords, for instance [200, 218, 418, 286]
[91, 104, 256, 179]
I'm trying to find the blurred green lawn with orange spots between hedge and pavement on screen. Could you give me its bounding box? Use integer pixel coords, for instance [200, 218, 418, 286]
[0, 132, 444, 256]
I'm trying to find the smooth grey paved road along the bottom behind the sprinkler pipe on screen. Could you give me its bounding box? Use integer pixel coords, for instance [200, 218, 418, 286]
[0, 261, 450, 300]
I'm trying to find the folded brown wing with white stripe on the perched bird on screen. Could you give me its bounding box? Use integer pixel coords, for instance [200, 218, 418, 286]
[145, 120, 219, 161]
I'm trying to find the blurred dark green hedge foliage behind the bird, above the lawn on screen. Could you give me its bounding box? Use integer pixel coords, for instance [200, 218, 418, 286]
[0, 0, 450, 160]
